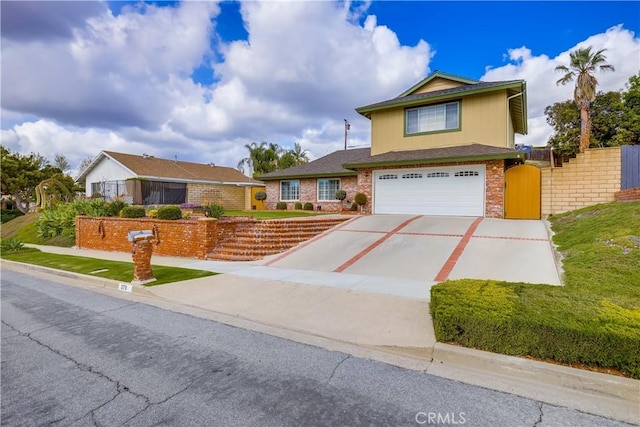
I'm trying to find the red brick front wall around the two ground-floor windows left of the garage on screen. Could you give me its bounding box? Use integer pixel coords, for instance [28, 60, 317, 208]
[265, 176, 357, 212]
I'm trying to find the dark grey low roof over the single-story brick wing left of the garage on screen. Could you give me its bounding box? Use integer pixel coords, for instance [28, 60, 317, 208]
[259, 147, 371, 181]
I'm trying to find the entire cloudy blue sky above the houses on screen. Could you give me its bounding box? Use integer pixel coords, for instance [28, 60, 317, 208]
[0, 0, 640, 174]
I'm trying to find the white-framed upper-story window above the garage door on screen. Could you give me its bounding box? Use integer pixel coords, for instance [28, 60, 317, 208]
[405, 101, 460, 135]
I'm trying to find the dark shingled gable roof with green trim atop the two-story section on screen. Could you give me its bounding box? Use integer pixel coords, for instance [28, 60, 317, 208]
[356, 72, 528, 135]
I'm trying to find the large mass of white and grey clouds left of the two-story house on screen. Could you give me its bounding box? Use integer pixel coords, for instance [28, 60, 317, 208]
[2, 2, 432, 166]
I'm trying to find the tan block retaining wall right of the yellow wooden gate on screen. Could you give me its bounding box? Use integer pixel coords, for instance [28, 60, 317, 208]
[541, 147, 621, 216]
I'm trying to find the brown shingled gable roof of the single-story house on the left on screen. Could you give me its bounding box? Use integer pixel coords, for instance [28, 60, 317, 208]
[76, 151, 262, 185]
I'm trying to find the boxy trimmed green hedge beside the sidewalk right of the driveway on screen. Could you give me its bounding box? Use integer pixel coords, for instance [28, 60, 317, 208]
[430, 279, 640, 378]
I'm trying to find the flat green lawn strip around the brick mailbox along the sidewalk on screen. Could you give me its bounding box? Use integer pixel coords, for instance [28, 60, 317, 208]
[2, 248, 217, 286]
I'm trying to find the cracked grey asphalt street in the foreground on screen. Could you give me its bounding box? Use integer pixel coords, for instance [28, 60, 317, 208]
[1, 270, 628, 427]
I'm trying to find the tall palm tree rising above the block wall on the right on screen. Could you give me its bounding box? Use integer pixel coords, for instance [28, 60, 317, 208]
[556, 46, 615, 153]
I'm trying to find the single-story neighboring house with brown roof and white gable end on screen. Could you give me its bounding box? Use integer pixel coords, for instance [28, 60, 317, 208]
[76, 151, 264, 210]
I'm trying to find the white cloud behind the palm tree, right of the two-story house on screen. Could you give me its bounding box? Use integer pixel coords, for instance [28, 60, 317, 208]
[482, 25, 640, 149]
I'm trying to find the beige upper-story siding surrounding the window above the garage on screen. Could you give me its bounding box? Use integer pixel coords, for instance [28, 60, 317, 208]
[371, 91, 513, 155]
